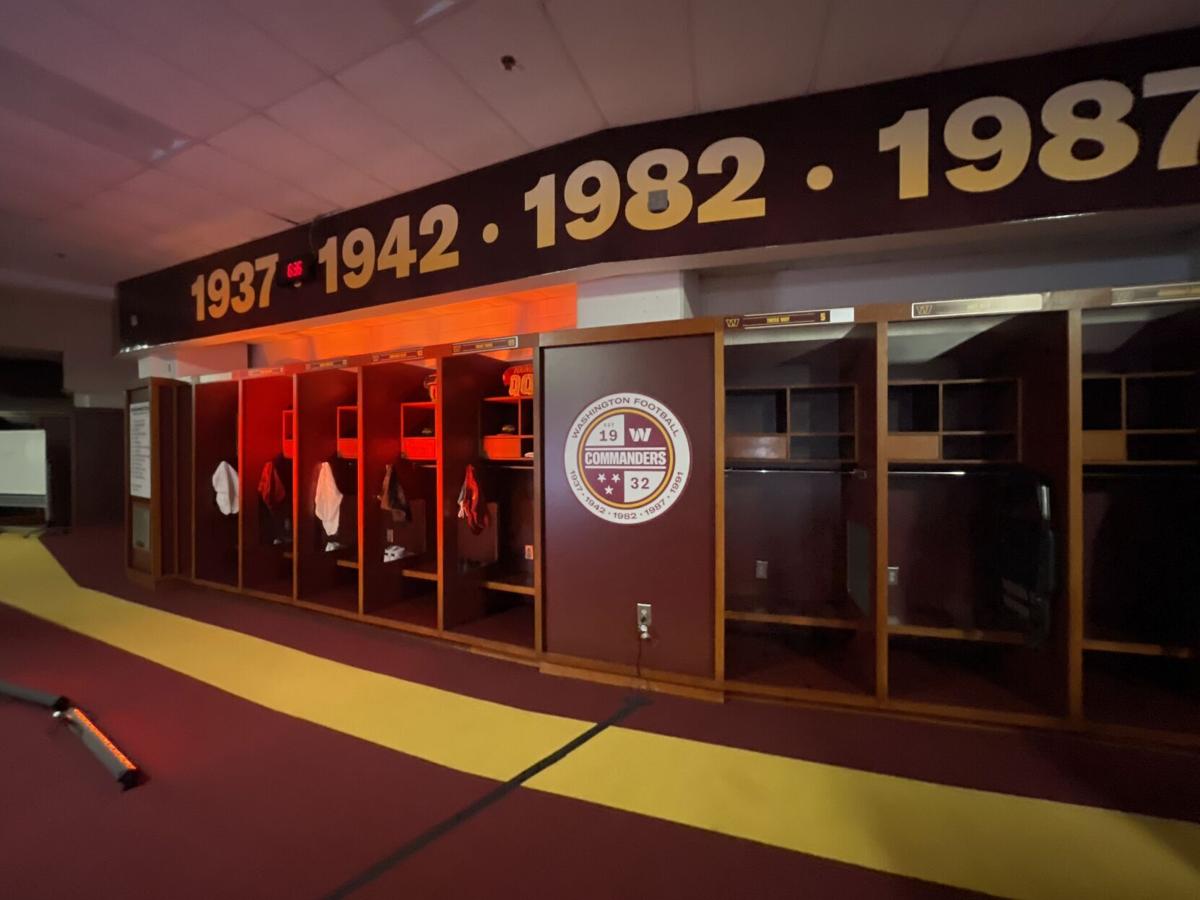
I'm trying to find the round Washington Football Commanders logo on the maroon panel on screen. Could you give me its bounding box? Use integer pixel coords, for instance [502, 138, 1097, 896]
[563, 394, 691, 524]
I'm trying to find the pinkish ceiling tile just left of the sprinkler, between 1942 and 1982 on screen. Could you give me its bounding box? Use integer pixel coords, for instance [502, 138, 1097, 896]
[337, 40, 529, 174]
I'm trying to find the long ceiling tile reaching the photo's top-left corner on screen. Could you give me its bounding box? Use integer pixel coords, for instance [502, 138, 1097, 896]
[0, 0, 246, 137]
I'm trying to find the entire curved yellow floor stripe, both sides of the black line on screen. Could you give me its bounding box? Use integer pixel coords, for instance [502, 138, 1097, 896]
[0, 535, 1200, 898]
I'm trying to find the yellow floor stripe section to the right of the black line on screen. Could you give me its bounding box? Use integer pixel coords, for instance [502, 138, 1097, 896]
[528, 728, 1200, 900]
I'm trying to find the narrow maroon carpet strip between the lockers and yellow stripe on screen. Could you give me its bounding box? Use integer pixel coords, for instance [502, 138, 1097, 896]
[35, 529, 1200, 821]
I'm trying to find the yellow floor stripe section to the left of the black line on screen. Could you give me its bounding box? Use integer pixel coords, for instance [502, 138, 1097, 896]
[0, 535, 593, 781]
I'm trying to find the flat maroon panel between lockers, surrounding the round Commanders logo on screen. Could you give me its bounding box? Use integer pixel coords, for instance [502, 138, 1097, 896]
[541, 335, 715, 677]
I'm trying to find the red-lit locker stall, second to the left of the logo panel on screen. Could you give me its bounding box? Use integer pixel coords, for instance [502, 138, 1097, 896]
[359, 360, 440, 630]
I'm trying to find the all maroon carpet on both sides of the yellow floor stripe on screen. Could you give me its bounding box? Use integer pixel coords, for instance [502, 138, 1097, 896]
[0, 532, 1200, 898]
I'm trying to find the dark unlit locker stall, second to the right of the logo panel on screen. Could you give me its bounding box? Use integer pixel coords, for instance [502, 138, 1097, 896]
[886, 312, 1070, 715]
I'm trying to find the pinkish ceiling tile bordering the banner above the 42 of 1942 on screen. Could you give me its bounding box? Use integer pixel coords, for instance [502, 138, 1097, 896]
[266, 79, 454, 193]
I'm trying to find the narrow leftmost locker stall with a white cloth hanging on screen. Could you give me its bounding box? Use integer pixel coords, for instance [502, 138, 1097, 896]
[193, 380, 237, 587]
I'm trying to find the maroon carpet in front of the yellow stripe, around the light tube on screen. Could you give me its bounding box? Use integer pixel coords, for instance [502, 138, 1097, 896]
[0, 592, 979, 900]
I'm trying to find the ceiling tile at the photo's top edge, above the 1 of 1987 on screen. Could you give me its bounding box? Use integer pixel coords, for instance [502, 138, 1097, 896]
[812, 0, 974, 92]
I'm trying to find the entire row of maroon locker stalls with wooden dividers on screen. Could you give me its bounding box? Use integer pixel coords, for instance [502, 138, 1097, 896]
[130, 283, 1200, 743]
